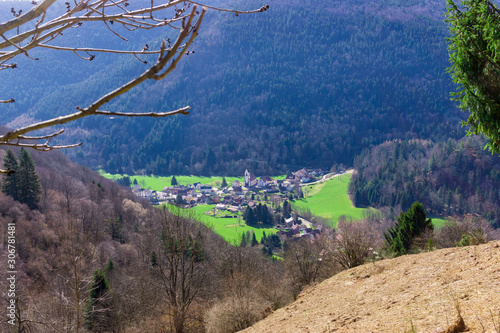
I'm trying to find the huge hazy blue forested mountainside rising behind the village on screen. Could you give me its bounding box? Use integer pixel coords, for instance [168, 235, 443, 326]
[0, 0, 464, 175]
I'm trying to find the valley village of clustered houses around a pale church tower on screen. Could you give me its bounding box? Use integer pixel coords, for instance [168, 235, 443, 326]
[132, 168, 330, 240]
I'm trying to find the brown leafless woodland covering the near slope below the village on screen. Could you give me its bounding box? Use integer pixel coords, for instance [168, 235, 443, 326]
[0, 150, 496, 332]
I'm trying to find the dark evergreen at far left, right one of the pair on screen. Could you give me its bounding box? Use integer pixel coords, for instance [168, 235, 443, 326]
[17, 149, 42, 209]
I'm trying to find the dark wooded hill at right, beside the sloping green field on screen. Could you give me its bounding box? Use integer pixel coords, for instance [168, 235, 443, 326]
[349, 138, 500, 226]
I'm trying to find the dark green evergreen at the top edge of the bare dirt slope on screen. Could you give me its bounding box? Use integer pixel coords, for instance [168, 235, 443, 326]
[384, 201, 434, 256]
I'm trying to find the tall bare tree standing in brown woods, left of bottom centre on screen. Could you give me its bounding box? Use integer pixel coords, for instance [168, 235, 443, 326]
[147, 208, 209, 333]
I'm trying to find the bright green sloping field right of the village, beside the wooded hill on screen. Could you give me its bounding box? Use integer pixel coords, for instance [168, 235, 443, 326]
[293, 173, 374, 227]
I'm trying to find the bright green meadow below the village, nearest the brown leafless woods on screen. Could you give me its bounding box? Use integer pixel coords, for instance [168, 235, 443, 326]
[175, 204, 278, 245]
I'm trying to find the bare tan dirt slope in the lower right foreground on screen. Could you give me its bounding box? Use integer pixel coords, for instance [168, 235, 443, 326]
[243, 241, 500, 333]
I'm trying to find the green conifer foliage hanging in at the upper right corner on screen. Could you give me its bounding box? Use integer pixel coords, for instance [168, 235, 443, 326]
[446, 0, 500, 154]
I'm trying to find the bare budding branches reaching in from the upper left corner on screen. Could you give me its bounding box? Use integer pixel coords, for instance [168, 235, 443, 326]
[0, 0, 269, 170]
